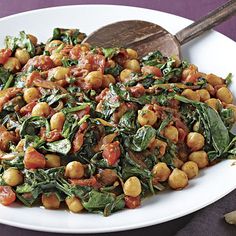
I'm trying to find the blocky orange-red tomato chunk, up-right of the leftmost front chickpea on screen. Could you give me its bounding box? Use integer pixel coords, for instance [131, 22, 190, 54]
[24, 147, 46, 169]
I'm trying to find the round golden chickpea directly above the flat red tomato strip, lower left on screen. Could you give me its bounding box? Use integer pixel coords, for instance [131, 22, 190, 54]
[65, 161, 84, 179]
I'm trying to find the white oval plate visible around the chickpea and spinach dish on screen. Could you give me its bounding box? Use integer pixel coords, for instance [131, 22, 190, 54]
[0, 5, 236, 233]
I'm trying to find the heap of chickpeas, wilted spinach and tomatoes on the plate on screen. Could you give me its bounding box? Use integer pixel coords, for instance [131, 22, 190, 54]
[0, 28, 236, 216]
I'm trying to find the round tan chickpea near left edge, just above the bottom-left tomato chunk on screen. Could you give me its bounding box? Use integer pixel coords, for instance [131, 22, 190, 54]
[2, 167, 23, 187]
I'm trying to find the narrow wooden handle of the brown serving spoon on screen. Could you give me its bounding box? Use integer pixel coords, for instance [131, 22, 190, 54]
[175, 0, 236, 45]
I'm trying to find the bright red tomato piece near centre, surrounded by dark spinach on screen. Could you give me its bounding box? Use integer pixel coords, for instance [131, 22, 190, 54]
[102, 141, 121, 165]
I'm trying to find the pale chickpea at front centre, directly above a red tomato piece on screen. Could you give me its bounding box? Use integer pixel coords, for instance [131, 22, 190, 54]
[123, 176, 142, 197]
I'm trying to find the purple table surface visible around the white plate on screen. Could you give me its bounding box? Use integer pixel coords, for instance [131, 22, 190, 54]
[0, 0, 236, 236]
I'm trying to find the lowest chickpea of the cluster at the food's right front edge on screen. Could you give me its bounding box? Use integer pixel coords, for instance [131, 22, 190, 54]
[168, 168, 188, 189]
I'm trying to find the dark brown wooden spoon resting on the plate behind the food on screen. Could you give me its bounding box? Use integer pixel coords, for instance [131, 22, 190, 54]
[84, 0, 236, 58]
